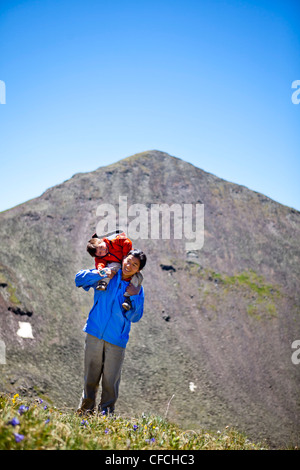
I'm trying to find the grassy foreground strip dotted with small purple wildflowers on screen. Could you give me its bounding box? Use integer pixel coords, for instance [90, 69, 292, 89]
[0, 395, 267, 450]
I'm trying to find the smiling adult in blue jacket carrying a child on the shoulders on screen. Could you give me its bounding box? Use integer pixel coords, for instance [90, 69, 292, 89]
[75, 250, 147, 413]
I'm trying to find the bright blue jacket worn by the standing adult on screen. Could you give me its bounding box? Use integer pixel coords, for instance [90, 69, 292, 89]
[75, 269, 144, 348]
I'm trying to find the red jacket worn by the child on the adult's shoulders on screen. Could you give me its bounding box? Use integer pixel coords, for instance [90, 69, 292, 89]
[95, 232, 132, 269]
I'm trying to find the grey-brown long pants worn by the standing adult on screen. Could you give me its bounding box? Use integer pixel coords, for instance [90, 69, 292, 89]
[79, 333, 125, 413]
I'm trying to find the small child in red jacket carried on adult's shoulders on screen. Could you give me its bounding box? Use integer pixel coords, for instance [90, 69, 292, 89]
[86, 231, 143, 310]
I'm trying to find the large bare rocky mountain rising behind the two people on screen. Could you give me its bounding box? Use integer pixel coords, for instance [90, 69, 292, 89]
[0, 150, 300, 447]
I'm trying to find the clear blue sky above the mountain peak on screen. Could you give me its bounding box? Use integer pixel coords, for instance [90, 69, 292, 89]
[0, 0, 300, 211]
